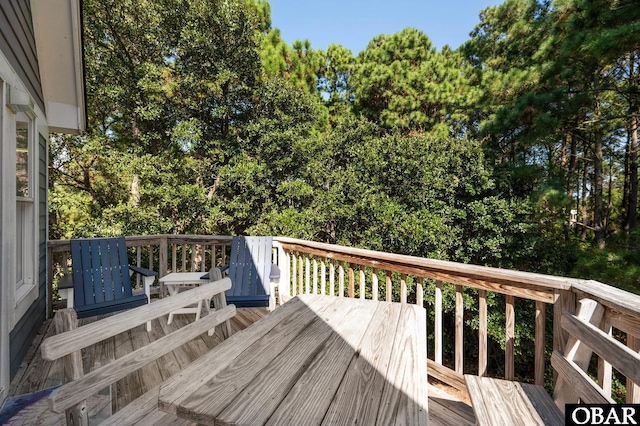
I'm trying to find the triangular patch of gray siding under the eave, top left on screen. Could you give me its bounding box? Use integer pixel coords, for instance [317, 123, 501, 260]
[0, 0, 45, 111]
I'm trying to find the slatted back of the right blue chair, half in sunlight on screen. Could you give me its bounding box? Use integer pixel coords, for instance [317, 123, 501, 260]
[227, 237, 272, 303]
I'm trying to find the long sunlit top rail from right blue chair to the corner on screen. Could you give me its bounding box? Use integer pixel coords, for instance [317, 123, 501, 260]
[274, 237, 582, 290]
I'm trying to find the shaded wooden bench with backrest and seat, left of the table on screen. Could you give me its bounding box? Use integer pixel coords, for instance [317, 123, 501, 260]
[41, 278, 236, 425]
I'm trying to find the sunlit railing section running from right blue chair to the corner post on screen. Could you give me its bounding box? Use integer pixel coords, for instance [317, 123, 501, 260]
[274, 238, 576, 389]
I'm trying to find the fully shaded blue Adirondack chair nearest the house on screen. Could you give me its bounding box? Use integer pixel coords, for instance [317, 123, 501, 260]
[70, 237, 158, 320]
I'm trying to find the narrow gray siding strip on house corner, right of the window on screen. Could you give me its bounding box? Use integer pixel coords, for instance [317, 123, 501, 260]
[9, 135, 48, 378]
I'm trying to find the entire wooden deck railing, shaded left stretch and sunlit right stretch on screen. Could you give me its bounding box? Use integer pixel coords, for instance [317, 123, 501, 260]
[48, 235, 640, 402]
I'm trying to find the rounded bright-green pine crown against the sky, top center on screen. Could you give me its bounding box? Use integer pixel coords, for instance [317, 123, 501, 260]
[351, 28, 479, 136]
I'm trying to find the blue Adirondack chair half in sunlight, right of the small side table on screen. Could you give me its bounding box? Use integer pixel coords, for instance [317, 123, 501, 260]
[202, 237, 280, 310]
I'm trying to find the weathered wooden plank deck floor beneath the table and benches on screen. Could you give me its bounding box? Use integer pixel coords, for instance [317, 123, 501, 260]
[9, 308, 475, 425]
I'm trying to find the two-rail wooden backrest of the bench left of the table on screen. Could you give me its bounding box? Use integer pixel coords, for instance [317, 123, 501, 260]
[41, 278, 236, 419]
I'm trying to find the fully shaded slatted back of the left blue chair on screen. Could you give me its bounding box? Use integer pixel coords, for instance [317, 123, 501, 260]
[71, 237, 132, 308]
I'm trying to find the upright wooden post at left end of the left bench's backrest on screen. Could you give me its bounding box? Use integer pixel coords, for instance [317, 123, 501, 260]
[53, 309, 89, 426]
